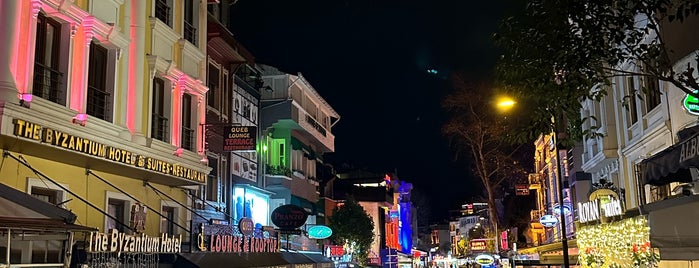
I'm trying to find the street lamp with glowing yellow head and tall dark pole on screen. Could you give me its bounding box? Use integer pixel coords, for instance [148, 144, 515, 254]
[496, 97, 570, 267]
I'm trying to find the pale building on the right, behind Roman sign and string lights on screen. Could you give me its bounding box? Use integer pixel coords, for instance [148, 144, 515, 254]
[579, 13, 699, 267]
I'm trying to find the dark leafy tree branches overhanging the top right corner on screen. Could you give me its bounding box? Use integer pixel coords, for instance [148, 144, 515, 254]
[495, 0, 699, 141]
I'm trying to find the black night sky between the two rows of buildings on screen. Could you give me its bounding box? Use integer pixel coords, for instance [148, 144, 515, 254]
[231, 0, 507, 221]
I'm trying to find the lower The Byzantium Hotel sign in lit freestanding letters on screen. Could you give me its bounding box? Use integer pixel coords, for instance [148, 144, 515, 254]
[87, 229, 182, 253]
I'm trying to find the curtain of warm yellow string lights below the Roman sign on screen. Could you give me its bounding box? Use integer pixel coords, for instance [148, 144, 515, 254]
[576, 216, 659, 268]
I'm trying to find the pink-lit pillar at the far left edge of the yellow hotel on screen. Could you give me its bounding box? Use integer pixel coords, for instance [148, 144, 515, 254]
[0, 1, 20, 99]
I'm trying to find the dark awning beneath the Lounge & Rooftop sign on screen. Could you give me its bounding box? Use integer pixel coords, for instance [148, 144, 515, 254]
[174, 252, 333, 268]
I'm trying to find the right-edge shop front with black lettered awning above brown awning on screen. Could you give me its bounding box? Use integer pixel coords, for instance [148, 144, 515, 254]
[639, 126, 699, 267]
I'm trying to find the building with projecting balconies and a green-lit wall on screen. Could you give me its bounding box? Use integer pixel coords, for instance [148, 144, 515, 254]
[257, 65, 340, 250]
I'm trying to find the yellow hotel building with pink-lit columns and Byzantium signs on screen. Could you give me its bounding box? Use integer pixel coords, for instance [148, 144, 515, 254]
[0, 0, 210, 264]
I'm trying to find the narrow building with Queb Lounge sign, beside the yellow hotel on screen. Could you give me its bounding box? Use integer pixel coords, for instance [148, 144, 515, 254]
[202, 0, 271, 226]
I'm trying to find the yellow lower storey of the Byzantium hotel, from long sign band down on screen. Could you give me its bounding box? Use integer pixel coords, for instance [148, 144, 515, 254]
[0, 112, 210, 267]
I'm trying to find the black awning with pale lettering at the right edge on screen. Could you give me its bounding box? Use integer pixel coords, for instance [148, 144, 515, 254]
[640, 131, 699, 186]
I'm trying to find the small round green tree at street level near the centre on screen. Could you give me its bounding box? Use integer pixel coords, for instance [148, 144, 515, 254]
[328, 196, 374, 265]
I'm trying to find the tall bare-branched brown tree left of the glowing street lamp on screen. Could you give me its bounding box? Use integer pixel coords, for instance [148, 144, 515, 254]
[442, 77, 522, 251]
